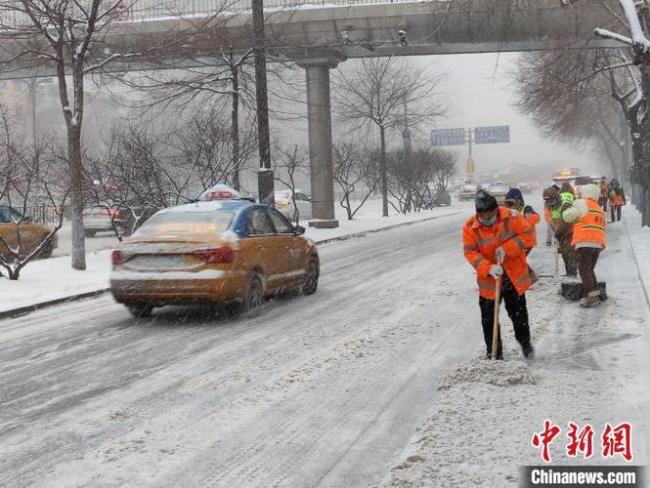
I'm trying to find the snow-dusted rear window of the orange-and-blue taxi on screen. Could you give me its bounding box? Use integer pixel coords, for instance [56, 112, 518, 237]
[135, 211, 234, 237]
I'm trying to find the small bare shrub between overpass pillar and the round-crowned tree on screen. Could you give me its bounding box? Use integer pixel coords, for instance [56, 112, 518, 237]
[334, 142, 378, 220]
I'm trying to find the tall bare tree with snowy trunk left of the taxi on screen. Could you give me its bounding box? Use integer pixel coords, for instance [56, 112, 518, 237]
[0, 0, 146, 270]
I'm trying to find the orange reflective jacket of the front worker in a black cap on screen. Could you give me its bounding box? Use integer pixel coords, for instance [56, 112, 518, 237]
[463, 207, 534, 300]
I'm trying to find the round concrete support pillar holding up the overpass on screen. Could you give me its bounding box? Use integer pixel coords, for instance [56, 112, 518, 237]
[298, 55, 344, 228]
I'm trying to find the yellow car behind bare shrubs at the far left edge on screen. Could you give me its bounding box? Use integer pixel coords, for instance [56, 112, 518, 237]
[0, 203, 58, 258]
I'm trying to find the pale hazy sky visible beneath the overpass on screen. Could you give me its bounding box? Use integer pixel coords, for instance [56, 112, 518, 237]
[271, 53, 603, 179]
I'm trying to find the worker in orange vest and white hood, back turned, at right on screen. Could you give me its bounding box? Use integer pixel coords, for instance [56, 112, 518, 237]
[562, 185, 607, 307]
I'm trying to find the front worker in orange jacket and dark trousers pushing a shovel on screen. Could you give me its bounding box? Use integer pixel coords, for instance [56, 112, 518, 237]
[462, 190, 534, 359]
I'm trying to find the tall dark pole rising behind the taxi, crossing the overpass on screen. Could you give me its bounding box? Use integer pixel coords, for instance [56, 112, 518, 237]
[252, 0, 273, 204]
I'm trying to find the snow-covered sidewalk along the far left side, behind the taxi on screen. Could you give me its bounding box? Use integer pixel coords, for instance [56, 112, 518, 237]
[0, 201, 458, 316]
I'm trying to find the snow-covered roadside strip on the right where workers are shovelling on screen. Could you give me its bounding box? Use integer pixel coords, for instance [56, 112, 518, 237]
[379, 207, 650, 488]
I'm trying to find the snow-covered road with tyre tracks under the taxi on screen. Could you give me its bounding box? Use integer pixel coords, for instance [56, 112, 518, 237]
[0, 216, 482, 488]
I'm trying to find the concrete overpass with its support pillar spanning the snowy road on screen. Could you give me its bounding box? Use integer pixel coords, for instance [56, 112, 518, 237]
[0, 0, 618, 224]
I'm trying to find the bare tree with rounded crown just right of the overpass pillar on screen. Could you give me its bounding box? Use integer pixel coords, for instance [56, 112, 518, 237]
[334, 57, 444, 217]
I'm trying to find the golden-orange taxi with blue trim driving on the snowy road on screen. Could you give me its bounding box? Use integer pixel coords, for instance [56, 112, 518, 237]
[111, 200, 320, 317]
